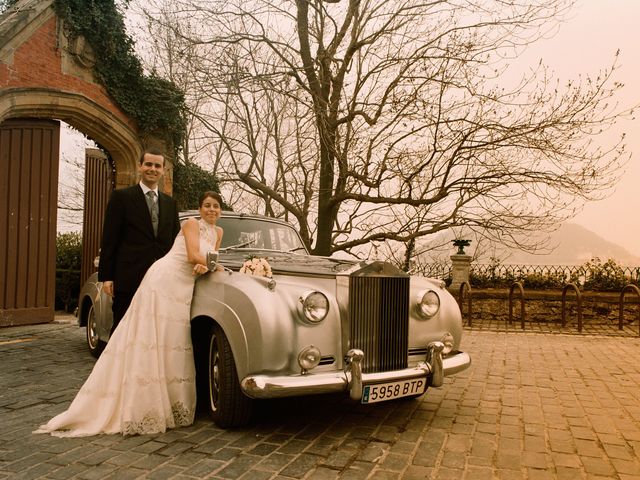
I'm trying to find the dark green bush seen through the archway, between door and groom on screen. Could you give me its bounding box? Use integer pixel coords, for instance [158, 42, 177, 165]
[55, 232, 82, 312]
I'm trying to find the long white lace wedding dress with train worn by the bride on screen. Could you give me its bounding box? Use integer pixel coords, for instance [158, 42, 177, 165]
[34, 220, 217, 437]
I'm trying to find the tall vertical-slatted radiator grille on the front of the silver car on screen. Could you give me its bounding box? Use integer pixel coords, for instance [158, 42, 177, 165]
[349, 276, 409, 373]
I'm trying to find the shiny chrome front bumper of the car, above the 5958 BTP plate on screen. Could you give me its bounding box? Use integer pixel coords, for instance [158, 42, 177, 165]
[240, 342, 471, 400]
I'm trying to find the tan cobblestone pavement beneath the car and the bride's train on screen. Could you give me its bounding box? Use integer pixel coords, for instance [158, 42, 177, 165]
[0, 316, 640, 480]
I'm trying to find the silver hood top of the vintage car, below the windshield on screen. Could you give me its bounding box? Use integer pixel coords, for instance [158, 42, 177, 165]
[220, 249, 366, 276]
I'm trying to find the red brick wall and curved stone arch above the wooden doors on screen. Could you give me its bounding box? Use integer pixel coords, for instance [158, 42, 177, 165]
[0, 0, 155, 186]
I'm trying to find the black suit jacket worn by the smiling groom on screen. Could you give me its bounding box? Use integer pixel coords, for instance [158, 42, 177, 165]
[98, 184, 180, 293]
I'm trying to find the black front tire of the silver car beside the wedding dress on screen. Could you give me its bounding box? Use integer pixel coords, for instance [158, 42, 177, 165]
[208, 325, 253, 428]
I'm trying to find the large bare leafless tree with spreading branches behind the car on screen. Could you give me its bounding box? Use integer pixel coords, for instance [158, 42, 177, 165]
[139, 0, 626, 258]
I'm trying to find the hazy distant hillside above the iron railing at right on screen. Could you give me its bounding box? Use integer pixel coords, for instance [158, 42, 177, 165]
[481, 223, 640, 267]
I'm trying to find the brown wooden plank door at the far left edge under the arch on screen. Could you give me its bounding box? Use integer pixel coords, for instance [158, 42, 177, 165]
[0, 119, 60, 326]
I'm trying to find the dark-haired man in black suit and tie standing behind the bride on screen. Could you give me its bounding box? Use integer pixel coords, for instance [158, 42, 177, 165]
[98, 149, 180, 335]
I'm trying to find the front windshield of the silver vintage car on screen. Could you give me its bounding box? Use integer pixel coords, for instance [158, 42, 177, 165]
[217, 215, 306, 253]
